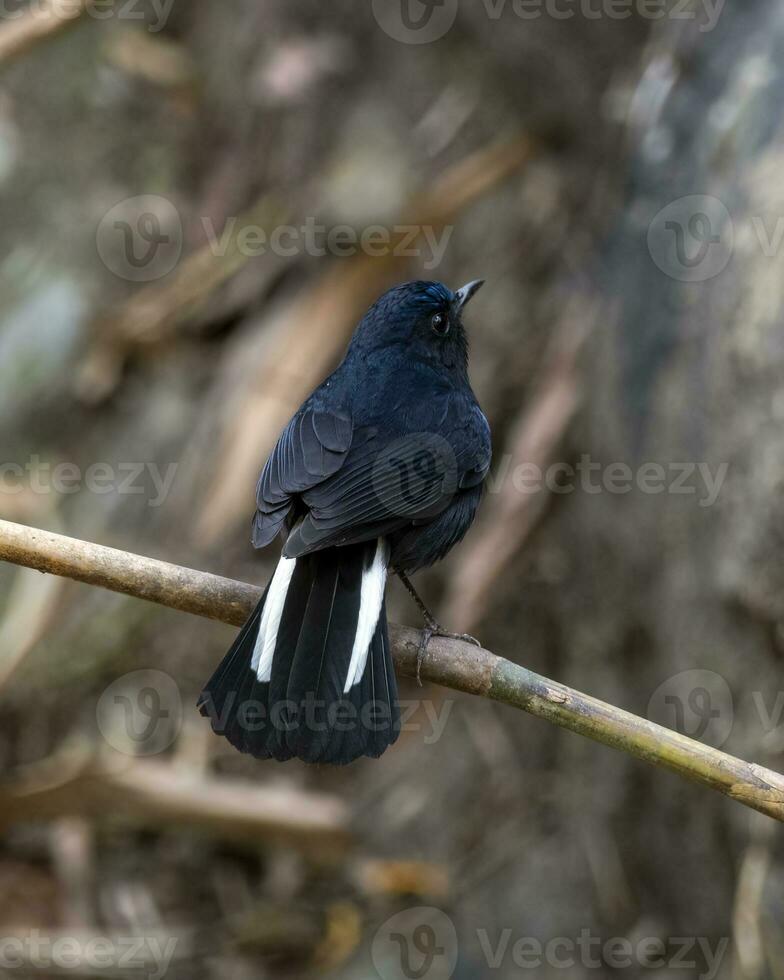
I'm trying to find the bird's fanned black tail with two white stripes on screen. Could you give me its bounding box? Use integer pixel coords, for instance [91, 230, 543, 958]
[198, 539, 400, 765]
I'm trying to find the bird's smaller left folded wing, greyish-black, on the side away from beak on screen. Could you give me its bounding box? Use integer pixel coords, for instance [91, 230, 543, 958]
[253, 402, 353, 548]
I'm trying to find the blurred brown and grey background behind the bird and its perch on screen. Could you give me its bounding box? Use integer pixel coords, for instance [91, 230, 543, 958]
[0, 0, 784, 980]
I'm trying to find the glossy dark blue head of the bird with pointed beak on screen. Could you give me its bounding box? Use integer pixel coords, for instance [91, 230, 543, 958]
[352, 279, 484, 371]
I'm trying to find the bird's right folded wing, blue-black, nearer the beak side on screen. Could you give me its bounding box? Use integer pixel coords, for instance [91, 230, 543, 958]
[284, 392, 490, 557]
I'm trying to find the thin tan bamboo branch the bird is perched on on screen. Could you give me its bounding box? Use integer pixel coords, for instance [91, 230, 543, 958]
[0, 521, 784, 822]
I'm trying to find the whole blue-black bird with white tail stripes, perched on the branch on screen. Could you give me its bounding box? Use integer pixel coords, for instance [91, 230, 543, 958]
[199, 280, 490, 764]
